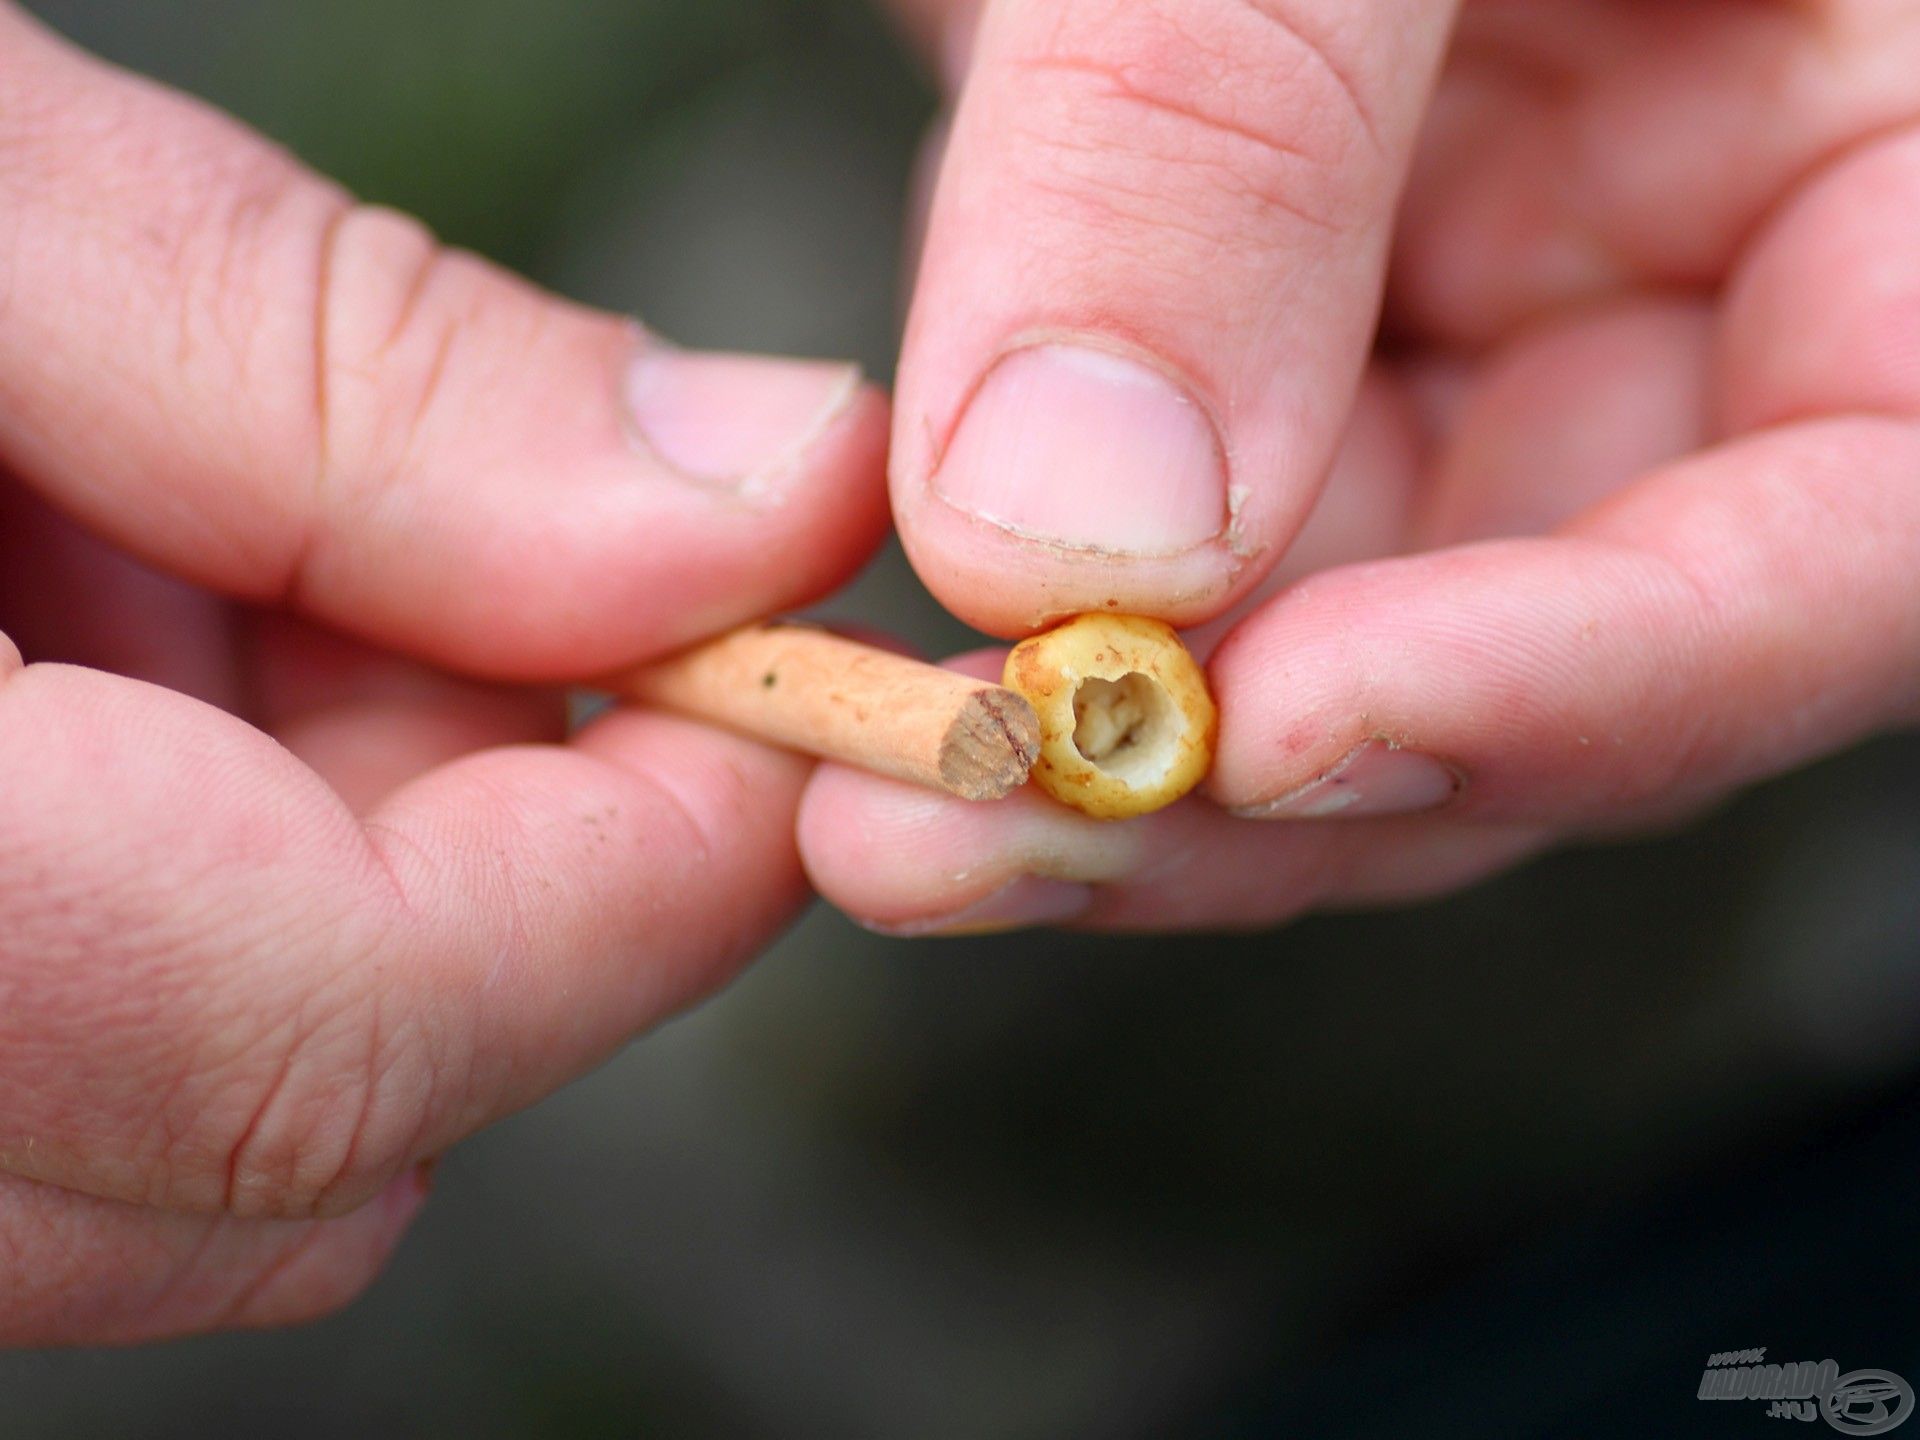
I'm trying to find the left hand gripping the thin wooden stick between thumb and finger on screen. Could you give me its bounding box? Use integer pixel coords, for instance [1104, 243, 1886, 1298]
[0, 8, 885, 1344]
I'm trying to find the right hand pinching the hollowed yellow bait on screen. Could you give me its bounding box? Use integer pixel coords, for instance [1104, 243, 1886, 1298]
[803, 0, 1920, 929]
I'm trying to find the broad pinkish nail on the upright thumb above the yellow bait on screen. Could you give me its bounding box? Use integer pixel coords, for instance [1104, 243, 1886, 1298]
[933, 344, 1227, 555]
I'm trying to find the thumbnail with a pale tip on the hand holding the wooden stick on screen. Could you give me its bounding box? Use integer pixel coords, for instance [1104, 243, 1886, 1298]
[626, 338, 860, 490]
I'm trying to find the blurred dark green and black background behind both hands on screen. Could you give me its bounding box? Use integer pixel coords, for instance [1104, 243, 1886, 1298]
[11, 0, 1920, 1440]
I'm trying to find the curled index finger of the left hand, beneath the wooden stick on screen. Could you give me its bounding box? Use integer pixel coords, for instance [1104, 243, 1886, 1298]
[0, 666, 804, 1215]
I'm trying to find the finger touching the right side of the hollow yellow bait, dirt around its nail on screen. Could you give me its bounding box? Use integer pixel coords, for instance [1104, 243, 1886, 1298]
[1212, 419, 1920, 826]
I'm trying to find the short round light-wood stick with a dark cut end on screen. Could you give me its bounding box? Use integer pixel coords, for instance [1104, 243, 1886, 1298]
[609, 620, 1041, 801]
